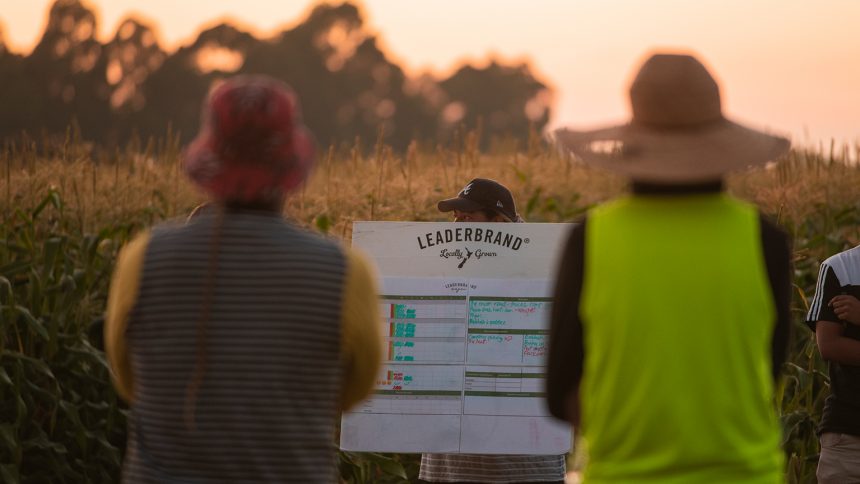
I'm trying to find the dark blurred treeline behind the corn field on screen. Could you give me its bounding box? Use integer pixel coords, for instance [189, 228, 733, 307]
[0, 0, 551, 148]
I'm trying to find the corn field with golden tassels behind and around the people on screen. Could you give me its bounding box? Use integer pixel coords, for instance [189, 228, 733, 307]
[0, 129, 860, 483]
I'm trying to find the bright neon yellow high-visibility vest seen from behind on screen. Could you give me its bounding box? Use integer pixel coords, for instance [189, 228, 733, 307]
[580, 194, 784, 484]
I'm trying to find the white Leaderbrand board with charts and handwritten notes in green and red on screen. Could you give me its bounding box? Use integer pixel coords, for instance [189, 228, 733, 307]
[340, 222, 571, 455]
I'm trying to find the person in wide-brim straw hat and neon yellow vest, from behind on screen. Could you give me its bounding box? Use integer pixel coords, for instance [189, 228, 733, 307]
[547, 53, 791, 484]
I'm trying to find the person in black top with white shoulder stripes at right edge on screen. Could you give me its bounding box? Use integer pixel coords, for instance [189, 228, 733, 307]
[806, 247, 860, 484]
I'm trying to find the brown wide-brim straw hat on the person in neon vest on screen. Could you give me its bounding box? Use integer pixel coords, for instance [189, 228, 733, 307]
[555, 54, 790, 184]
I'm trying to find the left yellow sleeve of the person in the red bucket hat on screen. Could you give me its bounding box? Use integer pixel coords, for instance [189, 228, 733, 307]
[104, 232, 150, 402]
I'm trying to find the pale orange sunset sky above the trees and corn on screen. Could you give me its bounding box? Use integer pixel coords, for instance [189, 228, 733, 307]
[0, 0, 860, 148]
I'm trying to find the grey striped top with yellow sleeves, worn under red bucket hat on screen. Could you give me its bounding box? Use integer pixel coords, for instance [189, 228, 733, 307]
[106, 211, 381, 483]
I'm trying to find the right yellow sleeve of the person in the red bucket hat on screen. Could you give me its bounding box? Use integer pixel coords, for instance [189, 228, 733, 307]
[340, 249, 382, 410]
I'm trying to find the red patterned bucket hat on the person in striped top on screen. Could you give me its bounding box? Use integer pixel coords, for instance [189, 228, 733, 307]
[182, 76, 314, 202]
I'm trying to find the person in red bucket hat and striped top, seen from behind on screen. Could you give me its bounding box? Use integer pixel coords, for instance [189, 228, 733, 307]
[105, 76, 382, 483]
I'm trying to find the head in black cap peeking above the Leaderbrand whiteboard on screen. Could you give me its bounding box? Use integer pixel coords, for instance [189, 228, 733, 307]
[437, 178, 523, 222]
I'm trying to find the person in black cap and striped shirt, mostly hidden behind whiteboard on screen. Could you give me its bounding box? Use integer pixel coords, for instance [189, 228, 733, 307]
[419, 178, 565, 484]
